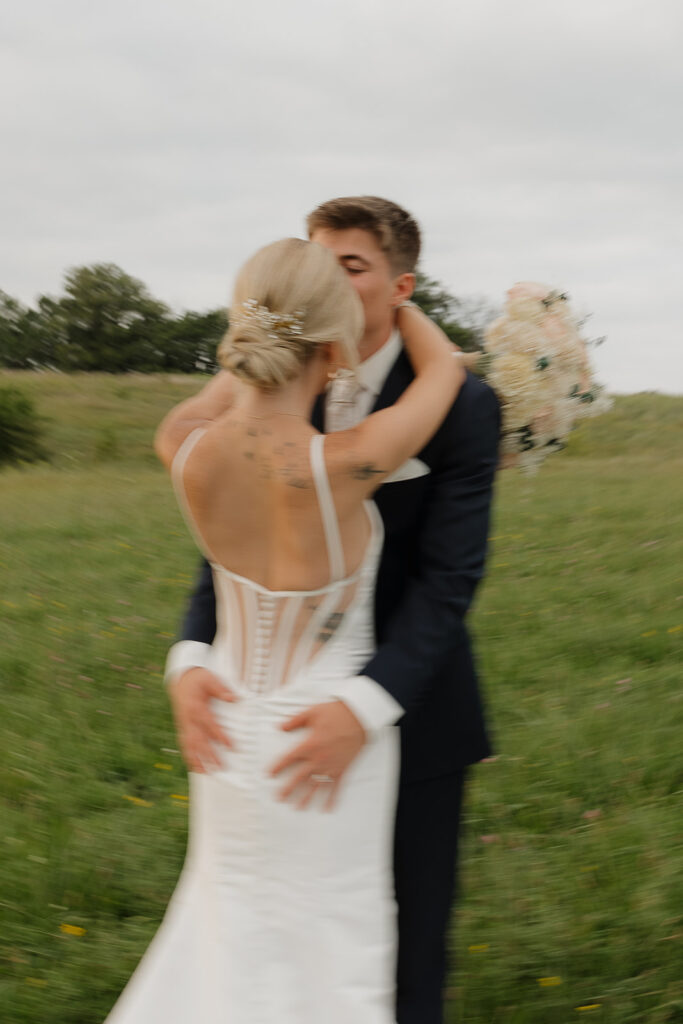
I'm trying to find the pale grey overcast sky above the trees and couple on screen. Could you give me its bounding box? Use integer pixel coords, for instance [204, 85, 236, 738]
[0, 0, 683, 393]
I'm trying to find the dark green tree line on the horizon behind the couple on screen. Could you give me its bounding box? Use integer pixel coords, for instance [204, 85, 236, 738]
[0, 263, 483, 373]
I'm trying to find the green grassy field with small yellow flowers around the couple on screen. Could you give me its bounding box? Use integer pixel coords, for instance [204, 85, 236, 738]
[0, 373, 683, 1024]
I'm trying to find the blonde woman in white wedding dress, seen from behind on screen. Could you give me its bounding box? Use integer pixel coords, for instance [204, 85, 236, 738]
[108, 239, 465, 1024]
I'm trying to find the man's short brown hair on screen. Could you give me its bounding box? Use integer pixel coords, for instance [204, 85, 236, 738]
[306, 196, 420, 274]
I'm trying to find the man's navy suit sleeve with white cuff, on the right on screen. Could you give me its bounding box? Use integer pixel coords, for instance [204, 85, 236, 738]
[339, 381, 500, 727]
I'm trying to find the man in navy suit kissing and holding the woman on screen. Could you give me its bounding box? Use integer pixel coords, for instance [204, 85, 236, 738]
[162, 197, 500, 1024]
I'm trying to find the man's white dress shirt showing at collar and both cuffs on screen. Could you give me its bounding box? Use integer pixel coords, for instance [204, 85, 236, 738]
[165, 330, 403, 734]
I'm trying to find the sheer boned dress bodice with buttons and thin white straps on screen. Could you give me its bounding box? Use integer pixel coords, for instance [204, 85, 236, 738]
[172, 428, 383, 693]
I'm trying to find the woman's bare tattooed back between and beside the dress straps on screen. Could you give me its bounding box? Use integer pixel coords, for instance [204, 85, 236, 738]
[174, 414, 370, 591]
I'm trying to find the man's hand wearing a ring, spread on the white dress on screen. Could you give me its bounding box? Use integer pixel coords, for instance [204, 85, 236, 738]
[270, 700, 366, 810]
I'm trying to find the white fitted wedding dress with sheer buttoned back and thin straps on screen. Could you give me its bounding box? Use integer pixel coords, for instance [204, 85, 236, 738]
[106, 430, 398, 1024]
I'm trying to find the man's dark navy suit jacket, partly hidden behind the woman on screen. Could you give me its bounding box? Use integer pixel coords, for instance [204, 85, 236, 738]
[182, 352, 500, 782]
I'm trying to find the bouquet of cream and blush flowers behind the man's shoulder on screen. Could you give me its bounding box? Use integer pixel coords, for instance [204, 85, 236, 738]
[465, 282, 611, 472]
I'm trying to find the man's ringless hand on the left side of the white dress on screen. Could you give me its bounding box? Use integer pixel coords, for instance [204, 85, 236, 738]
[169, 668, 238, 773]
